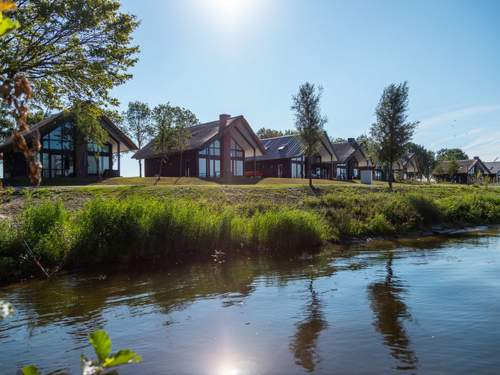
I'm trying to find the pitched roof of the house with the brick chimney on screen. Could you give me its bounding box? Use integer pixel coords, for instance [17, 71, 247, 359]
[132, 115, 265, 159]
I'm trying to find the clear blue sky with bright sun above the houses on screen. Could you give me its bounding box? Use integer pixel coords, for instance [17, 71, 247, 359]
[114, 0, 500, 176]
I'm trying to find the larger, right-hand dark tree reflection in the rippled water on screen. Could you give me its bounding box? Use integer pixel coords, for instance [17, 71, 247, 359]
[368, 252, 418, 370]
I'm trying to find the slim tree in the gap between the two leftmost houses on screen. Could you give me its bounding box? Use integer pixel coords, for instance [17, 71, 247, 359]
[122, 101, 153, 177]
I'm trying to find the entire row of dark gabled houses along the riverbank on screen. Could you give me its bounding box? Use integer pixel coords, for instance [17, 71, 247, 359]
[0, 113, 500, 183]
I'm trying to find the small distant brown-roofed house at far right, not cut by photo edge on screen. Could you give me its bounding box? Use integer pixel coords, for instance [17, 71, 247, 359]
[432, 156, 490, 184]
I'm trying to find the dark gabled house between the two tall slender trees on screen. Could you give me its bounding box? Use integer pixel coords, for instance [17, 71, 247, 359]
[332, 138, 371, 180]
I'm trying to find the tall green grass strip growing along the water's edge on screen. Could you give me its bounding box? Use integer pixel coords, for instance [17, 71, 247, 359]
[0, 188, 500, 282]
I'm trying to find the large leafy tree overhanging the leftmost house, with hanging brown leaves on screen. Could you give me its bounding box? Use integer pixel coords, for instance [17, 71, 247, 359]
[0, 0, 138, 185]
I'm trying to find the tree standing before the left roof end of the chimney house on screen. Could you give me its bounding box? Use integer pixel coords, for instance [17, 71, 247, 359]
[153, 103, 198, 182]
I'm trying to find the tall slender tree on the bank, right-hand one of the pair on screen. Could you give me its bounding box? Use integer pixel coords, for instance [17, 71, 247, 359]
[371, 82, 418, 190]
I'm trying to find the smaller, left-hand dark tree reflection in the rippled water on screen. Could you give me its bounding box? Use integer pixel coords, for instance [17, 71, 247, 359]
[290, 279, 327, 372]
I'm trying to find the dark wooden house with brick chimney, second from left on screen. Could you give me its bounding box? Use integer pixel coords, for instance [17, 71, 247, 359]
[133, 114, 265, 181]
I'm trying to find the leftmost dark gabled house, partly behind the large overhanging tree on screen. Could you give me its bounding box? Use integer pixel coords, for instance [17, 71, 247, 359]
[0, 112, 137, 181]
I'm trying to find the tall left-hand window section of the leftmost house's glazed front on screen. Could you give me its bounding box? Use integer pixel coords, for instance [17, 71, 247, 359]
[40, 121, 75, 178]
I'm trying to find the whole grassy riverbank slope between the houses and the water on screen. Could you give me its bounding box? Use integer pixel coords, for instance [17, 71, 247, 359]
[0, 184, 500, 282]
